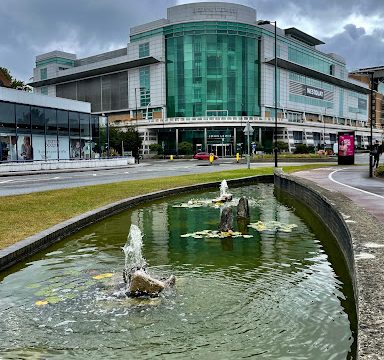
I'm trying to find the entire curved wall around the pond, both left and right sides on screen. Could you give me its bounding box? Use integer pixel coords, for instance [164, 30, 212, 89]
[0, 171, 384, 359]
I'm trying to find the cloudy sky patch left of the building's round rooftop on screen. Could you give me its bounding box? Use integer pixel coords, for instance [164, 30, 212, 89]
[0, 0, 175, 81]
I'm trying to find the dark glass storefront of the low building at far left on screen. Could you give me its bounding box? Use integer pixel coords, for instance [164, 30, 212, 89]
[0, 101, 100, 162]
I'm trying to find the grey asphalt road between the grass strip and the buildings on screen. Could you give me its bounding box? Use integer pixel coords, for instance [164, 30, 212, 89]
[0, 153, 367, 196]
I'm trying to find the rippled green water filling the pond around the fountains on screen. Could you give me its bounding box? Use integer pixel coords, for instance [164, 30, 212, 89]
[0, 185, 356, 360]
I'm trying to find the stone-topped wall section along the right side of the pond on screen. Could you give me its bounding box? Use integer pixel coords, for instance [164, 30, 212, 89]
[274, 170, 384, 360]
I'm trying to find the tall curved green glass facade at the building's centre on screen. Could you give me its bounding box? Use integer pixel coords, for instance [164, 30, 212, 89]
[165, 22, 260, 117]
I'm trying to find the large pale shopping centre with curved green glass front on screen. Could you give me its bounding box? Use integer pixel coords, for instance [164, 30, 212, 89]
[30, 2, 382, 155]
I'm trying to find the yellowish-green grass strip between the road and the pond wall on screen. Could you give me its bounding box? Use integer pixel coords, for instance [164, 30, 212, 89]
[0, 164, 329, 249]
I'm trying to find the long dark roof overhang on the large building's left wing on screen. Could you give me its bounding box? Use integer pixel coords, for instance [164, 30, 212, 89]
[28, 56, 160, 87]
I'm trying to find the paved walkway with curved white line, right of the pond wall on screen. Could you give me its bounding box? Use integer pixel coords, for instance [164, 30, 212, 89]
[294, 166, 384, 224]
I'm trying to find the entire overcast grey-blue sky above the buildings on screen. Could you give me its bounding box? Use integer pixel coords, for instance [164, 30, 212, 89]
[0, 0, 384, 82]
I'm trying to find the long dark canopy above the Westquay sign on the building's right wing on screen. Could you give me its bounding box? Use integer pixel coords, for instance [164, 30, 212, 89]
[266, 58, 370, 94]
